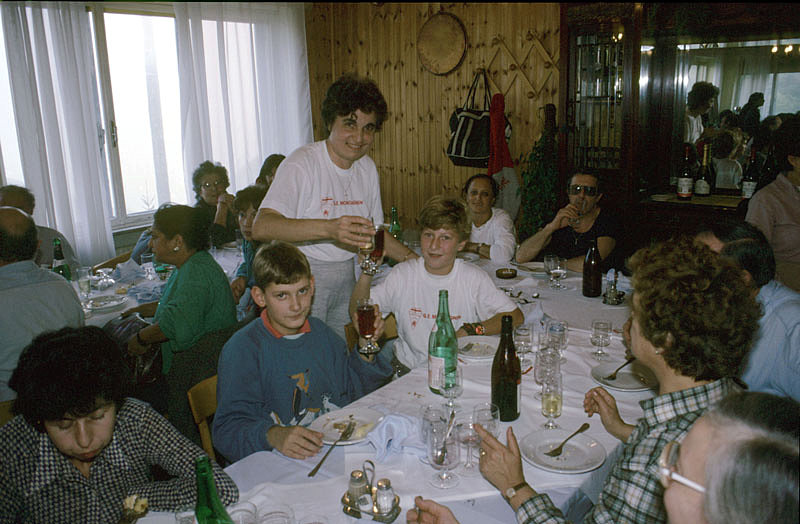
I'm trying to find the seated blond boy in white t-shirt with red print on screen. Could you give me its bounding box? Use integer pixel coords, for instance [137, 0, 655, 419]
[350, 196, 523, 368]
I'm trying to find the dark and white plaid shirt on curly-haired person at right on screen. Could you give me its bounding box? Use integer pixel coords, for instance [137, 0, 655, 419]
[517, 378, 739, 524]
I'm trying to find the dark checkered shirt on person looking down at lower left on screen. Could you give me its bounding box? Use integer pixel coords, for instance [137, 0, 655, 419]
[0, 399, 239, 524]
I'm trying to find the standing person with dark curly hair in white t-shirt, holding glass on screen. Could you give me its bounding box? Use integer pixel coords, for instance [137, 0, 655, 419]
[252, 75, 417, 338]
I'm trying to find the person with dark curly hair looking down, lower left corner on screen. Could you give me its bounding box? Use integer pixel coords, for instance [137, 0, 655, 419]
[0, 327, 238, 524]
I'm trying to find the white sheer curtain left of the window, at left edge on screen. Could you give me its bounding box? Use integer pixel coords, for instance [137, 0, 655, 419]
[0, 2, 114, 264]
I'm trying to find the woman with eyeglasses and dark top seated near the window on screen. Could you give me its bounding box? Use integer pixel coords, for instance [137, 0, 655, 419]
[192, 160, 238, 247]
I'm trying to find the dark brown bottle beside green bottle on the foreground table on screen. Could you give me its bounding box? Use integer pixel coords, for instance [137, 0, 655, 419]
[492, 315, 522, 422]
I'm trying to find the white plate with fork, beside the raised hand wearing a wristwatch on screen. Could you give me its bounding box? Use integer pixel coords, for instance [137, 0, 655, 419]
[519, 429, 606, 473]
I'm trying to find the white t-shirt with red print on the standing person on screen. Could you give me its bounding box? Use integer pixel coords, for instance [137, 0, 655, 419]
[261, 140, 383, 262]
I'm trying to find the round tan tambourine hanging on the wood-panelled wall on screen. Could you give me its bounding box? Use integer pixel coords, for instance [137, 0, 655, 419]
[417, 11, 467, 75]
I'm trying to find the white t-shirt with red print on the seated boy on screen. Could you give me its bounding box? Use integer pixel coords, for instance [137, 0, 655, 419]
[370, 257, 517, 368]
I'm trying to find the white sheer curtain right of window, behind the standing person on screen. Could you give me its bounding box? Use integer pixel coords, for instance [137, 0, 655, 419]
[173, 2, 313, 194]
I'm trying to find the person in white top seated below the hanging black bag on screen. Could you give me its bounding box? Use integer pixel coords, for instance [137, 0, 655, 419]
[461, 174, 517, 264]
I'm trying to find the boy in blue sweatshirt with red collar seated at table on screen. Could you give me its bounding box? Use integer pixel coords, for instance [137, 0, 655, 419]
[213, 242, 392, 461]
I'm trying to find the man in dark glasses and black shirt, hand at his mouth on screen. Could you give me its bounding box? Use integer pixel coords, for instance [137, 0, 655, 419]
[516, 170, 619, 272]
